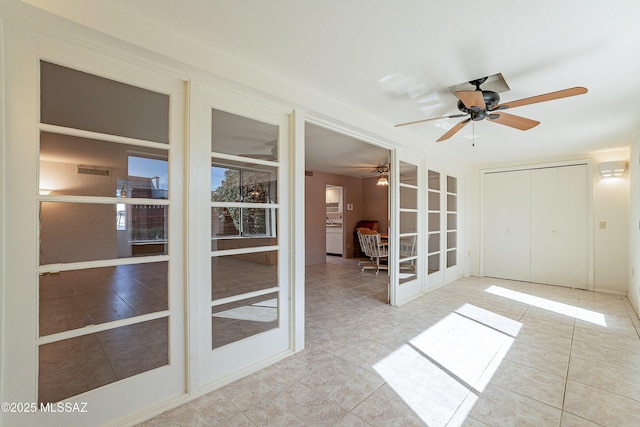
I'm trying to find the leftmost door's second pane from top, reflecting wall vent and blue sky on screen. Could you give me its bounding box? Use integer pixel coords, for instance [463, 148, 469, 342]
[40, 132, 169, 199]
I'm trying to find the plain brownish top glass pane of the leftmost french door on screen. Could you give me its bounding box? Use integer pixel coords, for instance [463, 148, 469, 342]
[40, 61, 169, 144]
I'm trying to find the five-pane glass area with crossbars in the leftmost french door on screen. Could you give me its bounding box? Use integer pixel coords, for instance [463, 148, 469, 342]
[37, 61, 179, 402]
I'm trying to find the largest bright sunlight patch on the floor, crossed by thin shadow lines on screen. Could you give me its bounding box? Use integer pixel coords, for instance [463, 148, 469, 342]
[373, 304, 522, 426]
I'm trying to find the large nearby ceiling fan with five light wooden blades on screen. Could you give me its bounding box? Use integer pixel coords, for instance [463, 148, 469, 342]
[395, 77, 587, 142]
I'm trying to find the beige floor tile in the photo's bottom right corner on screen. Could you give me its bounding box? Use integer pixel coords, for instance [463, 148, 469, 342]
[564, 380, 640, 427]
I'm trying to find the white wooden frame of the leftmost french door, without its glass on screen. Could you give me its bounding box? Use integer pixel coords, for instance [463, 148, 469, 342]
[1, 22, 186, 425]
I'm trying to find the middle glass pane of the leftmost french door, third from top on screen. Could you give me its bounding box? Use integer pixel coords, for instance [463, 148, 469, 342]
[40, 202, 168, 265]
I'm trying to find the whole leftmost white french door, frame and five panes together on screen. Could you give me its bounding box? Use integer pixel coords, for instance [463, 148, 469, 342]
[2, 24, 186, 425]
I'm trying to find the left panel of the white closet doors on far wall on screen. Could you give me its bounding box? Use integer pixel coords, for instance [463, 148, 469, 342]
[483, 170, 531, 280]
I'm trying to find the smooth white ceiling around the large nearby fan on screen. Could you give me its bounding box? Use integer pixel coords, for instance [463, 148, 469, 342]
[15, 0, 640, 171]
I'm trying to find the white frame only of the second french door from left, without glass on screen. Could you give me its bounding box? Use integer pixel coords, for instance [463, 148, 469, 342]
[187, 82, 295, 395]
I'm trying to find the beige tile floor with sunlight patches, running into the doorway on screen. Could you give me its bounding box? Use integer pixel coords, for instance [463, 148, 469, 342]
[142, 263, 640, 427]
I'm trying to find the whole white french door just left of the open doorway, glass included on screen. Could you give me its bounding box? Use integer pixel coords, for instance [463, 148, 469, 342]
[190, 86, 291, 389]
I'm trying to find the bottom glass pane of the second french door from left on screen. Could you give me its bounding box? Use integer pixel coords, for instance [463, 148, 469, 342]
[211, 292, 278, 348]
